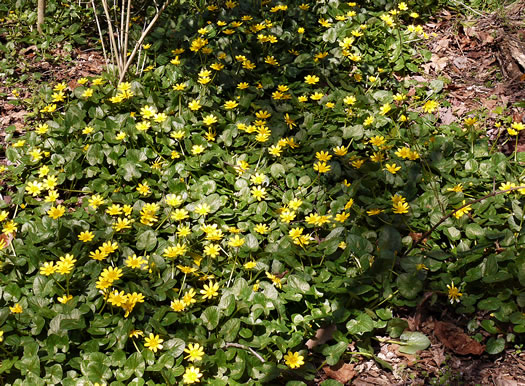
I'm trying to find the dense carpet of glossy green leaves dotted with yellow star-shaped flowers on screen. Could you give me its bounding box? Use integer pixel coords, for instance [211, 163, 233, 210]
[0, 0, 525, 385]
